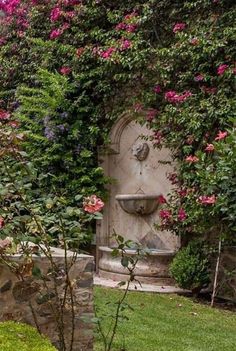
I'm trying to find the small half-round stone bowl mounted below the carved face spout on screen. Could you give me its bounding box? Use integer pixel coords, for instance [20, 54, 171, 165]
[115, 193, 161, 216]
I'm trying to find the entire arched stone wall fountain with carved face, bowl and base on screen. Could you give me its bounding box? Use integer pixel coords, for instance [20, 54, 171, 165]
[96, 116, 179, 285]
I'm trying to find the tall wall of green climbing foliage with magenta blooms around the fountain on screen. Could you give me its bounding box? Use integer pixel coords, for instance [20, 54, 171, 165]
[0, 0, 236, 240]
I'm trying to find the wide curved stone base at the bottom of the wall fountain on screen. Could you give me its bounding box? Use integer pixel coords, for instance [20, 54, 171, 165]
[99, 246, 175, 285]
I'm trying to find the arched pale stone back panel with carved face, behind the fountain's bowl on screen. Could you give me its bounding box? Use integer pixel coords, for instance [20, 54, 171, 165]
[96, 115, 179, 286]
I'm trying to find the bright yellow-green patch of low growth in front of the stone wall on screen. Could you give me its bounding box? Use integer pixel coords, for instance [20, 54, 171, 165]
[0, 322, 56, 351]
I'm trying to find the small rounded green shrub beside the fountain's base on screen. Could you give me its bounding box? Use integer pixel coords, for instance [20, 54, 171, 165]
[170, 241, 210, 294]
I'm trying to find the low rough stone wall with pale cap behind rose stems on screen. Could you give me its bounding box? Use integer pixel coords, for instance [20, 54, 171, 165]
[0, 249, 94, 351]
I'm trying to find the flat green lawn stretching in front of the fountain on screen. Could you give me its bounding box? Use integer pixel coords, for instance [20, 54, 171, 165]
[95, 288, 236, 351]
